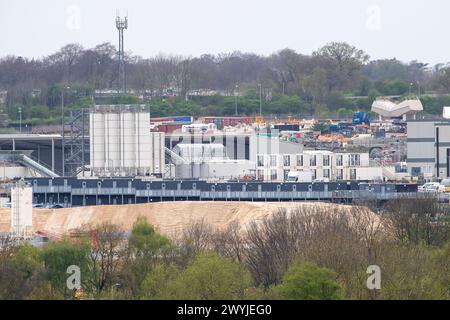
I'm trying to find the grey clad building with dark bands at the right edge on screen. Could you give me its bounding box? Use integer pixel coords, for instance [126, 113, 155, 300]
[407, 119, 450, 179]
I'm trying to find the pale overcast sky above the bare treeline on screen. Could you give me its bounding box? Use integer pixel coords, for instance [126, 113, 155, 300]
[0, 0, 450, 64]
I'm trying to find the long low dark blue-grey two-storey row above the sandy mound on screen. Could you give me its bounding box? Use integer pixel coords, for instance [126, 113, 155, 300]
[25, 178, 417, 207]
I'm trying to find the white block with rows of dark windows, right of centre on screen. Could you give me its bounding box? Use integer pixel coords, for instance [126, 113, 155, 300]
[256, 150, 383, 181]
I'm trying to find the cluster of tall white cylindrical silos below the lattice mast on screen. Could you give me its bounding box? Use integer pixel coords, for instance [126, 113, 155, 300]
[90, 106, 160, 176]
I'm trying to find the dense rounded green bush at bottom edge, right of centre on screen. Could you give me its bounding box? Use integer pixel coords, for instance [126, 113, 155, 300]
[274, 262, 343, 300]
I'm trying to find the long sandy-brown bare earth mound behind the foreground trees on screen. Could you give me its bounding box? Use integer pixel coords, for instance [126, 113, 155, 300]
[0, 201, 376, 236]
